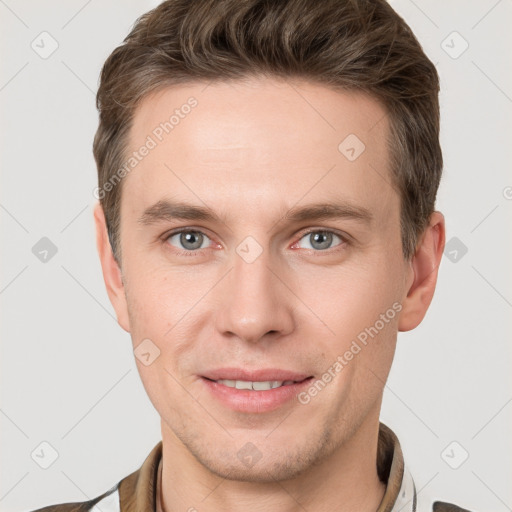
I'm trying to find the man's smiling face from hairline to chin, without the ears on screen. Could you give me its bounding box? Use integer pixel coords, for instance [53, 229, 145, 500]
[102, 78, 418, 481]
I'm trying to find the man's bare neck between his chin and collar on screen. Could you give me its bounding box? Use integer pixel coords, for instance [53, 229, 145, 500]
[159, 411, 386, 512]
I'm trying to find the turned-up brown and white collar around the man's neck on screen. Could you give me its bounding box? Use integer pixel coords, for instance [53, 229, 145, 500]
[118, 422, 417, 512]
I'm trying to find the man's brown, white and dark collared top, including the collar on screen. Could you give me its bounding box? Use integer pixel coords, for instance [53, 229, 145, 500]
[28, 422, 476, 512]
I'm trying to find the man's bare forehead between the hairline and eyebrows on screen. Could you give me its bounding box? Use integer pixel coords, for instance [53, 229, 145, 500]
[122, 78, 392, 220]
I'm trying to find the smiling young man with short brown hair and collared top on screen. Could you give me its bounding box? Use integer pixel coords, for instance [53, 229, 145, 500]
[30, 0, 474, 512]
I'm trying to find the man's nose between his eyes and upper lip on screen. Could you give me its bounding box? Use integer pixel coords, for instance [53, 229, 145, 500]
[216, 243, 296, 343]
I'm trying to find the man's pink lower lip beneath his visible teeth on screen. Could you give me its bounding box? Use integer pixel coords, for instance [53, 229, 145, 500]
[201, 377, 313, 413]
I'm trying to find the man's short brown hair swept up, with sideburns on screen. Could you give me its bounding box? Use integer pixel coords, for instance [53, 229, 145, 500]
[93, 0, 443, 262]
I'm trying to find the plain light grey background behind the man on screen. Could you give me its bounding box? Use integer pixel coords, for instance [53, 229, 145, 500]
[0, 0, 512, 512]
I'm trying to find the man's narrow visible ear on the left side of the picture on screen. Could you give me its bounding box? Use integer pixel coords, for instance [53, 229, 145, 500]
[94, 202, 130, 332]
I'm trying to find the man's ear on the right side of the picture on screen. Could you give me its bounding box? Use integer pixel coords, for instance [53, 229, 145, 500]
[398, 212, 445, 331]
